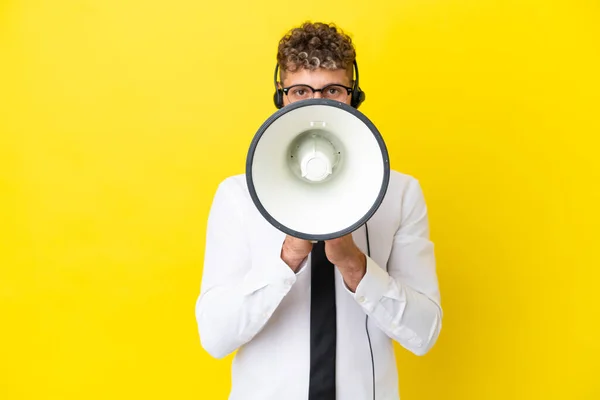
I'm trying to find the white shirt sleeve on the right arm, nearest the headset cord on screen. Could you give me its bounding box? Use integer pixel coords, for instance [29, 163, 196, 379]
[350, 180, 442, 355]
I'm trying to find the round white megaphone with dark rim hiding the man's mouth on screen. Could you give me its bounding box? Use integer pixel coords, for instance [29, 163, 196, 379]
[246, 98, 390, 241]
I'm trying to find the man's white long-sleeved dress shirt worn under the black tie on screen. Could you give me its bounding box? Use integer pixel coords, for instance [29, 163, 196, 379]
[195, 171, 442, 400]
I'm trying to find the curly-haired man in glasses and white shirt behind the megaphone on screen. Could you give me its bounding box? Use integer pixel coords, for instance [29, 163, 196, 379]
[196, 23, 442, 400]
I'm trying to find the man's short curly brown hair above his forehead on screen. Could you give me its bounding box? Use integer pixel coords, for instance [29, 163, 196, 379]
[277, 22, 356, 79]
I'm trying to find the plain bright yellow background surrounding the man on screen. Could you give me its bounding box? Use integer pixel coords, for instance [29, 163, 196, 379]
[0, 0, 600, 400]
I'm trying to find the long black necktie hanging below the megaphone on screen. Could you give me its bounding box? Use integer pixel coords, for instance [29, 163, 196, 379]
[308, 241, 336, 400]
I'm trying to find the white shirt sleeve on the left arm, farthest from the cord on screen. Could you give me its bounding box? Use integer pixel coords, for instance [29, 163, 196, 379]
[195, 178, 306, 358]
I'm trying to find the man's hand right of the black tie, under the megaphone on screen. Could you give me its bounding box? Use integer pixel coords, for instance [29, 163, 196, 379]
[325, 234, 367, 292]
